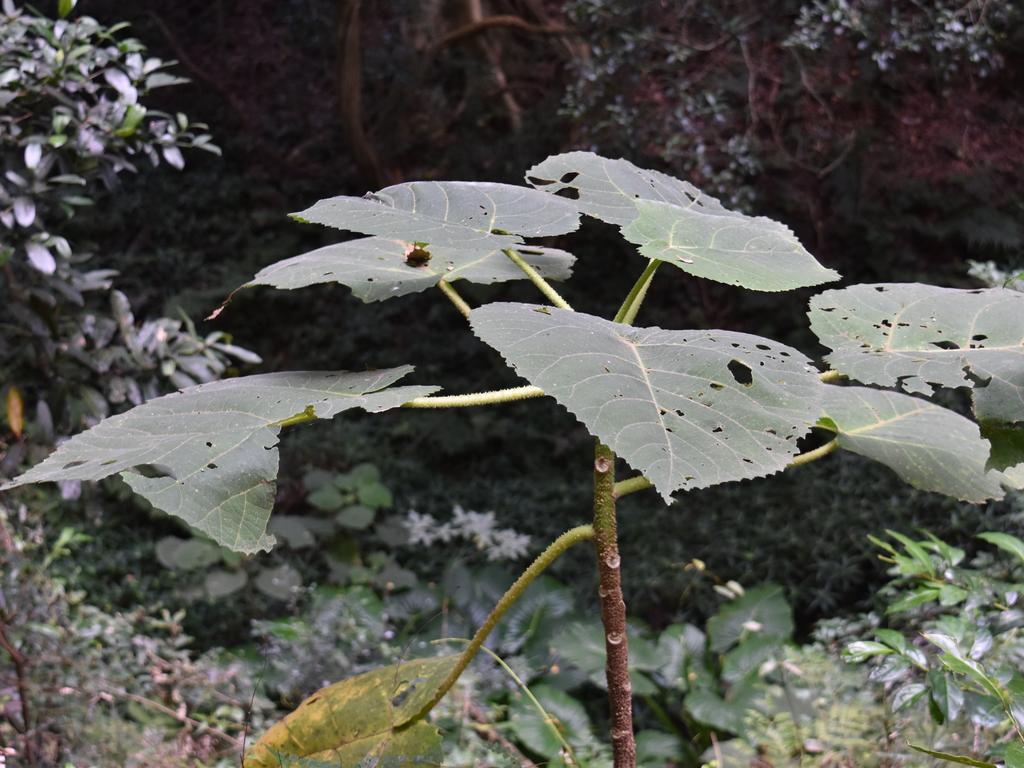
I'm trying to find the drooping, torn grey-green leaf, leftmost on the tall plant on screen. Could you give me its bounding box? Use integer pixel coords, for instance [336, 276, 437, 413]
[0, 366, 436, 553]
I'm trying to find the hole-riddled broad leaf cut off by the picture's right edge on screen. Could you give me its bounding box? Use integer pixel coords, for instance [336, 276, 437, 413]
[810, 283, 1024, 424]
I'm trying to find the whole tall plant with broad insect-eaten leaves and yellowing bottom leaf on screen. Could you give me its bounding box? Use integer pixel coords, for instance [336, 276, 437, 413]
[5, 152, 1024, 768]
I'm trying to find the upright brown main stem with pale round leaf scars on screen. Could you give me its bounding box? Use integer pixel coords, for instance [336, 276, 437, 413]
[594, 442, 637, 768]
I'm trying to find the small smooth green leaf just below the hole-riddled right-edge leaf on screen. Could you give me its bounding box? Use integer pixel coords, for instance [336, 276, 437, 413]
[822, 386, 1006, 502]
